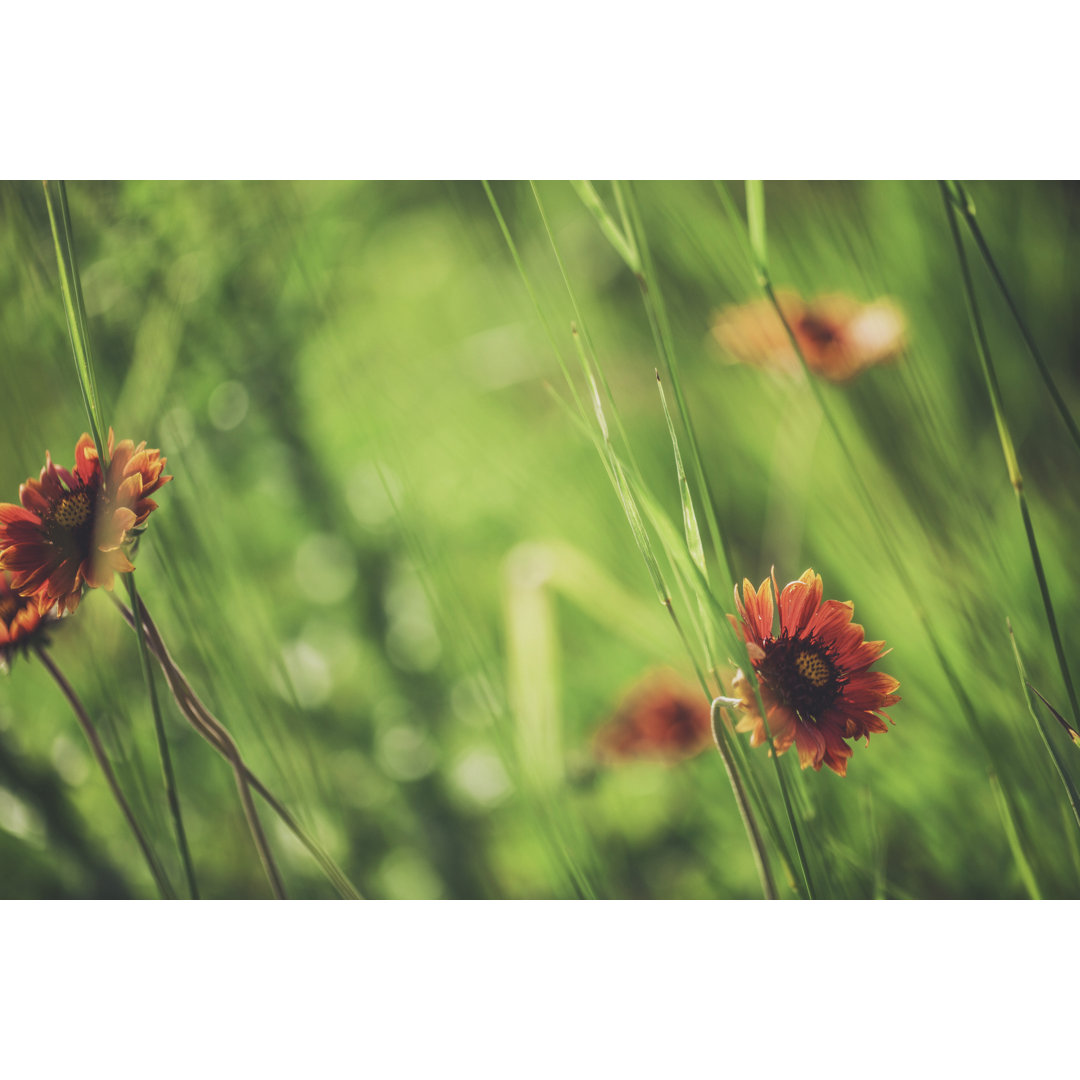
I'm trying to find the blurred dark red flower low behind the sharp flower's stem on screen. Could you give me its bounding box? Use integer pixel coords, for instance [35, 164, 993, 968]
[594, 671, 713, 762]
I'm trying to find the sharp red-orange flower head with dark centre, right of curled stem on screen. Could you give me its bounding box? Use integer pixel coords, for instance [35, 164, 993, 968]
[728, 570, 900, 777]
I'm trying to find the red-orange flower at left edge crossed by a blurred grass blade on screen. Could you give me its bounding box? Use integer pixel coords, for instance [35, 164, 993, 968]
[0, 429, 173, 615]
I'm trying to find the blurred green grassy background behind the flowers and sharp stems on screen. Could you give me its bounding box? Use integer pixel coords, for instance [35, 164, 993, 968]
[0, 183, 1080, 897]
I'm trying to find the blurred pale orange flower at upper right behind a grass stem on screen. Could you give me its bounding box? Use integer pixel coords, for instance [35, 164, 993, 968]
[713, 289, 906, 382]
